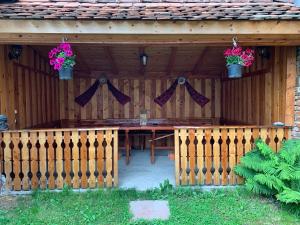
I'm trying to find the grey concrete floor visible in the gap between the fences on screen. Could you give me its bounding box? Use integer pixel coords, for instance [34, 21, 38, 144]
[119, 149, 175, 191]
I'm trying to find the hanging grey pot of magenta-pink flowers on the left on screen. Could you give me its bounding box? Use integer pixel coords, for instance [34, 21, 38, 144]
[48, 42, 76, 80]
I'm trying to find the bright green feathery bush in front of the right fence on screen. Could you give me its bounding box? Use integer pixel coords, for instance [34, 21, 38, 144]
[235, 140, 300, 208]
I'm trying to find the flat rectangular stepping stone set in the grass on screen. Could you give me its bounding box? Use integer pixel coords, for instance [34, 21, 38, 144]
[129, 200, 170, 220]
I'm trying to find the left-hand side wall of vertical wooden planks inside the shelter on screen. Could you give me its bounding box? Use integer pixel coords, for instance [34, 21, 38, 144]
[0, 45, 59, 129]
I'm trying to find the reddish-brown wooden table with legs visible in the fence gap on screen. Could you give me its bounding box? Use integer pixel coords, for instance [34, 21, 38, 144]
[120, 125, 174, 164]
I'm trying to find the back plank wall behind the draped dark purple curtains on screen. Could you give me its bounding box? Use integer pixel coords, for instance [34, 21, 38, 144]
[59, 76, 221, 120]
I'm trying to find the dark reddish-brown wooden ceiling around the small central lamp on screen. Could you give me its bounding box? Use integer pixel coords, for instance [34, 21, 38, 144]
[34, 44, 226, 78]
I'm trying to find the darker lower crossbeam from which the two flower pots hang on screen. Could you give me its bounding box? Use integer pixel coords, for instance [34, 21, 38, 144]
[0, 33, 300, 46]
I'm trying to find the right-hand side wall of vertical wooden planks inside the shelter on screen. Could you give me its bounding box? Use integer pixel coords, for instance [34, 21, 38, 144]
[221, 47, 296, 125]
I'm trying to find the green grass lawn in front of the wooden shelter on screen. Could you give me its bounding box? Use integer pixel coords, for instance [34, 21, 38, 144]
[0, 188, 300, 225]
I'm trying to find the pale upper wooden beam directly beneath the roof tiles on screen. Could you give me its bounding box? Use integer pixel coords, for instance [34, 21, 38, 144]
[0, 20, 300, 35]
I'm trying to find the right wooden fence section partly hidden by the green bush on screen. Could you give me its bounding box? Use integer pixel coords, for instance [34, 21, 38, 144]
[175, 127, 290, 185]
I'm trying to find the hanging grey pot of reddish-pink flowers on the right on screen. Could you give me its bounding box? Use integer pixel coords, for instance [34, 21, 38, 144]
[224, 46, 254, 78]
